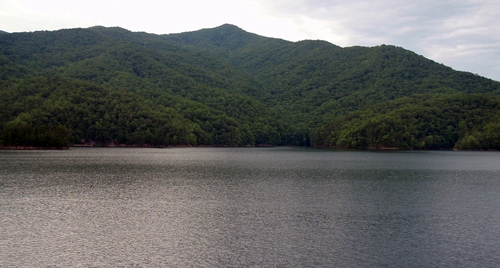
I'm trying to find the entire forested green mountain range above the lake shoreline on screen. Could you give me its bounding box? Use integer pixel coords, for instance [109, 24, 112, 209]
[0, 25, 500, 150]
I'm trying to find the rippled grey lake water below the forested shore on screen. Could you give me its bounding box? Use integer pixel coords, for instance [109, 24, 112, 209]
[0, 148, 500, 267]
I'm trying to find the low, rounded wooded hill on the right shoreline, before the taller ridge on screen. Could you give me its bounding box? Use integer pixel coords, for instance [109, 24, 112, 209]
[313, 94, 500, 149]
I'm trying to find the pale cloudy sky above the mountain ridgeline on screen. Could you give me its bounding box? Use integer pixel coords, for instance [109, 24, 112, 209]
[0, 0, 500, 81]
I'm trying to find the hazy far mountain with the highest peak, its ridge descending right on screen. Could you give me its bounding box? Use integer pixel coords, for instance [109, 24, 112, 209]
[166, 25, 500, 126]
